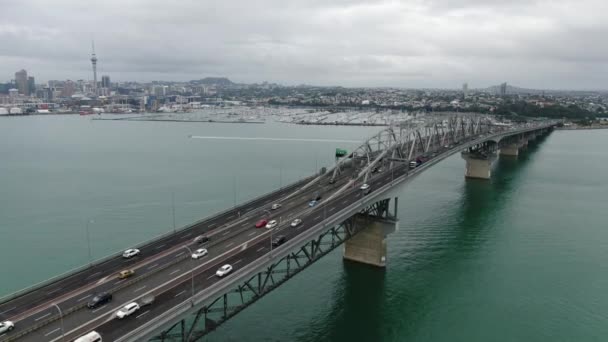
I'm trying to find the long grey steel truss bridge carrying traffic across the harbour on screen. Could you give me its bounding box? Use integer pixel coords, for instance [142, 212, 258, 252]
[0, 115, 557, 341]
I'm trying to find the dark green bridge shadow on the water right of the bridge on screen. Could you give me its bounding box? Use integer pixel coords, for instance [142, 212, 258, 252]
[294, 132, 547, 342]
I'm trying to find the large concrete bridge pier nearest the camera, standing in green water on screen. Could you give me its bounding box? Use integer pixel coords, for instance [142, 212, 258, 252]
[344, 214, 398, 267]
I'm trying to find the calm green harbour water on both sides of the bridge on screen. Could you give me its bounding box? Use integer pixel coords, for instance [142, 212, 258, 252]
[0, 117, 608, 341]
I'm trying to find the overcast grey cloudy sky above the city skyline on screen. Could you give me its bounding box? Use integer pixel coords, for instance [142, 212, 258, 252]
[0, 0, 608, 89]
